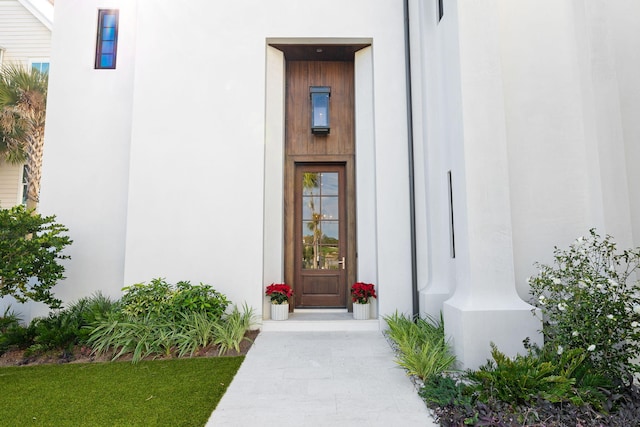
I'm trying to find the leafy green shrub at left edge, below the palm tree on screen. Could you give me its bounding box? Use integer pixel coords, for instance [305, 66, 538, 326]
[0, 206, 72, 308]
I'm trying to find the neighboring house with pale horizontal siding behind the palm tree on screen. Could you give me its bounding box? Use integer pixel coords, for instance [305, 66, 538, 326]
[0, 0, 53, 208]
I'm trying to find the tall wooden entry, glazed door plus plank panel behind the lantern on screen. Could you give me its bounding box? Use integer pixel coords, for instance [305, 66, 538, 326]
[284, 49, 356, 308]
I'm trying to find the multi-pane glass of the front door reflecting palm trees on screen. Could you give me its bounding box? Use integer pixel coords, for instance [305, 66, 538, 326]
[301, 172, 340, 270]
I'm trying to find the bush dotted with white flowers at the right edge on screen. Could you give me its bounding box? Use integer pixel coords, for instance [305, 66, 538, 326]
[529, 229, 640, 385]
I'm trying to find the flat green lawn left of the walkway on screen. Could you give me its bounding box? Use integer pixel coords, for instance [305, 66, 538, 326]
[0, 357, 244, 427]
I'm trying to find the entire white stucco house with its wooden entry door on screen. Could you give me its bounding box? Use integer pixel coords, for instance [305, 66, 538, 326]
[15, 0, 640, 367]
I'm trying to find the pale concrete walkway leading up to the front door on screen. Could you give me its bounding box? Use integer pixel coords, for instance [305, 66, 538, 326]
[207, 331, 437, 427]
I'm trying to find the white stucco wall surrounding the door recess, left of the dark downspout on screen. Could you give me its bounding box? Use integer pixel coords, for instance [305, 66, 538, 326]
[37, 0, 411, 320]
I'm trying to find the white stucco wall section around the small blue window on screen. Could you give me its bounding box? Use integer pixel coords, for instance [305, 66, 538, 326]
[39, 0, 136, 318]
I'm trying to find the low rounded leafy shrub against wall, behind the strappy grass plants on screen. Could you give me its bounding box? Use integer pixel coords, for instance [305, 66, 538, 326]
[120, 278, 229, 322]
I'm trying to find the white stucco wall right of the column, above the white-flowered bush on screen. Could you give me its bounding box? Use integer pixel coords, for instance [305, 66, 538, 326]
[499, 0, 640, 297]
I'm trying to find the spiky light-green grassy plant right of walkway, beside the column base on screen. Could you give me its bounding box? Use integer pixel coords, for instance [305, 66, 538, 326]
[384, 313, 456, 380]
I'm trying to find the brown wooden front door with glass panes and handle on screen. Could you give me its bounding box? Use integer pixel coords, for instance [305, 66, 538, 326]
[294, 163, 347, 307]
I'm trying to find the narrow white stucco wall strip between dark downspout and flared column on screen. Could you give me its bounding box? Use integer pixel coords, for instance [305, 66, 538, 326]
[409, 1, 461, 318]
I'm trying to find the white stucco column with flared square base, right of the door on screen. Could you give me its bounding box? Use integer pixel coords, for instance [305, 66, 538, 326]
[443, 0, 540, 368]
